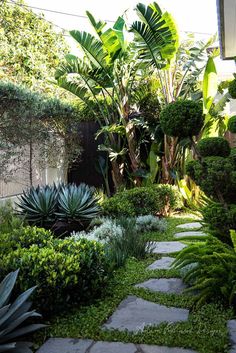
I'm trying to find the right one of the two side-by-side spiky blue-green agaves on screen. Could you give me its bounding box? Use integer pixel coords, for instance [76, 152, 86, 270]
[56, 183, 100, 222]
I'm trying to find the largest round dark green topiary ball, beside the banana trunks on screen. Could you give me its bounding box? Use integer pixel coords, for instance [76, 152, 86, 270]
[160, 100, 204, 138]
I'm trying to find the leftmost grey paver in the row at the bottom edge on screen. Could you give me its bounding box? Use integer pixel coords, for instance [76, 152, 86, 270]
[37, 338, 93, 353]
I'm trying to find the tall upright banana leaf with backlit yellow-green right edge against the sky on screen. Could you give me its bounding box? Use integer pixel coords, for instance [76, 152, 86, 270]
[131, 2, 178, 69]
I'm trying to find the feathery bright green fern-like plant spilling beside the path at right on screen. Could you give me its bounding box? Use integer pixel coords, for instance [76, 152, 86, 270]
[174, 237, 236, 305]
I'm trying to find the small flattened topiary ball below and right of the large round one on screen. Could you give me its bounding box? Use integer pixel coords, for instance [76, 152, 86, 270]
[197, 137, 231, 157]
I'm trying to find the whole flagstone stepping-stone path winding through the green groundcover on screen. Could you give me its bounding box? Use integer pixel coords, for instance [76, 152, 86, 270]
[37, 222, 236, 353]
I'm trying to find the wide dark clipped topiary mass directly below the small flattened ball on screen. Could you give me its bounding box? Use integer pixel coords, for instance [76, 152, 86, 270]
[186, 156, 236, 203]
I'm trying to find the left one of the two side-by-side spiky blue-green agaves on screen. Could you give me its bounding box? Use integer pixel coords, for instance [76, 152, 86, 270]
[18, 184, 58, 226]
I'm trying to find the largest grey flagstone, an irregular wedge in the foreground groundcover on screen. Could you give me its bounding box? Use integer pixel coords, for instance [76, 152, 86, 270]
[103, 296, 189, 332]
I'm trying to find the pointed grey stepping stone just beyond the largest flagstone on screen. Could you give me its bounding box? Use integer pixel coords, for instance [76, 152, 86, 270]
[135, 278, 186, 294]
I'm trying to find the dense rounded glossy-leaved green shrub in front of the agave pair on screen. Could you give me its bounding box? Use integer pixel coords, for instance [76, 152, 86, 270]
[0, 234, 107, 313]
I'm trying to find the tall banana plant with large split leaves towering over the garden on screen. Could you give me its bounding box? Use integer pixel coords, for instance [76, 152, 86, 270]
[55, 3, 177, 188]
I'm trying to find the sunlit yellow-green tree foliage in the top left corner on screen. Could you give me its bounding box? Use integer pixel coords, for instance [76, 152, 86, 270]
[0, 0, 68, 93]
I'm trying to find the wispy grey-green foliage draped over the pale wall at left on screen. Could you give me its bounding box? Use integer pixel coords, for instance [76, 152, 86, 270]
[0, 82, 81, 185]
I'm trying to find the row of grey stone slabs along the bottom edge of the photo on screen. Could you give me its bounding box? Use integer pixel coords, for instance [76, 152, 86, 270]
[37, 338, 197, 353]
